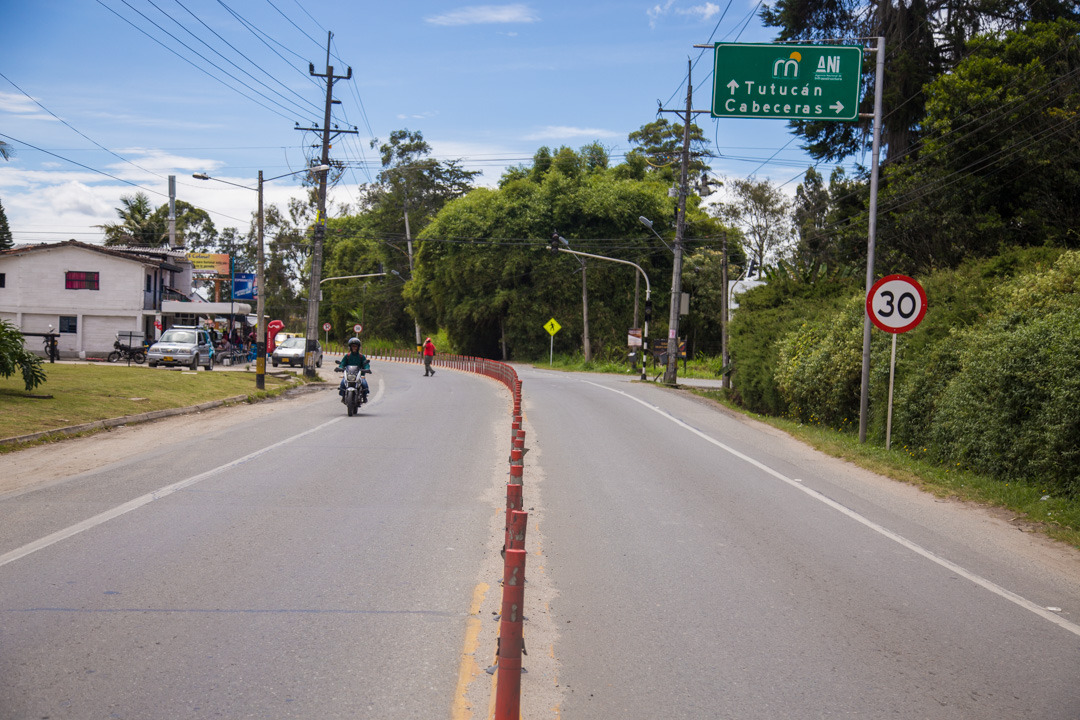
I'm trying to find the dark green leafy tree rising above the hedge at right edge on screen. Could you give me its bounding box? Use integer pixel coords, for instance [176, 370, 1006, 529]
[880, 21, 1080, 270]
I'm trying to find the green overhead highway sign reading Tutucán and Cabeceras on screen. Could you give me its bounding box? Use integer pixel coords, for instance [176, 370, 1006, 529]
[713, 42, 863, 120]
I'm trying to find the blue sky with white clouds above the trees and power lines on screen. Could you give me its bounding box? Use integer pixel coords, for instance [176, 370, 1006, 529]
[0, 0, 859, 244]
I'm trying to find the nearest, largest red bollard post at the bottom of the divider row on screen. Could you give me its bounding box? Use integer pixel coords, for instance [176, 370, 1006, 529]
[495, 549, 526, 720]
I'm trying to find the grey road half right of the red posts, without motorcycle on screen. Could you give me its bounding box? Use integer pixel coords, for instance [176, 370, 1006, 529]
[519, 370, 1080, 720]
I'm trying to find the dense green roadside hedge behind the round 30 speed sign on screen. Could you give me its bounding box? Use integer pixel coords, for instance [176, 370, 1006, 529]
[731, 248, 1080, 494]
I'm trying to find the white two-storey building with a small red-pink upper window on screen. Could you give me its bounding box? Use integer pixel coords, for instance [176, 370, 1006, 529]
[0, 240, 191, 357]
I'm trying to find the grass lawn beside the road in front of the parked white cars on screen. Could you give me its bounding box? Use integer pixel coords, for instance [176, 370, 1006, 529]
[0, 363, 315, 438]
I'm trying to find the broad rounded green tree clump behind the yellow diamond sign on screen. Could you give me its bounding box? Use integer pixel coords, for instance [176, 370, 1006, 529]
[406, 146, 719, 358]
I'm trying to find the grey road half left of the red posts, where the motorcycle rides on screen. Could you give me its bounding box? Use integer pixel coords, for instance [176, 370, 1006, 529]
[0, 363, 510, 720]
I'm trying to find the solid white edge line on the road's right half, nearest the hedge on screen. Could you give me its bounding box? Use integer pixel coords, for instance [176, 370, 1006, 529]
[582, 380, 1080, 636]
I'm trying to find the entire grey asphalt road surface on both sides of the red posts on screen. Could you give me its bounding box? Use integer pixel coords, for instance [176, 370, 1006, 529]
[0, 362, 1080, 720]
